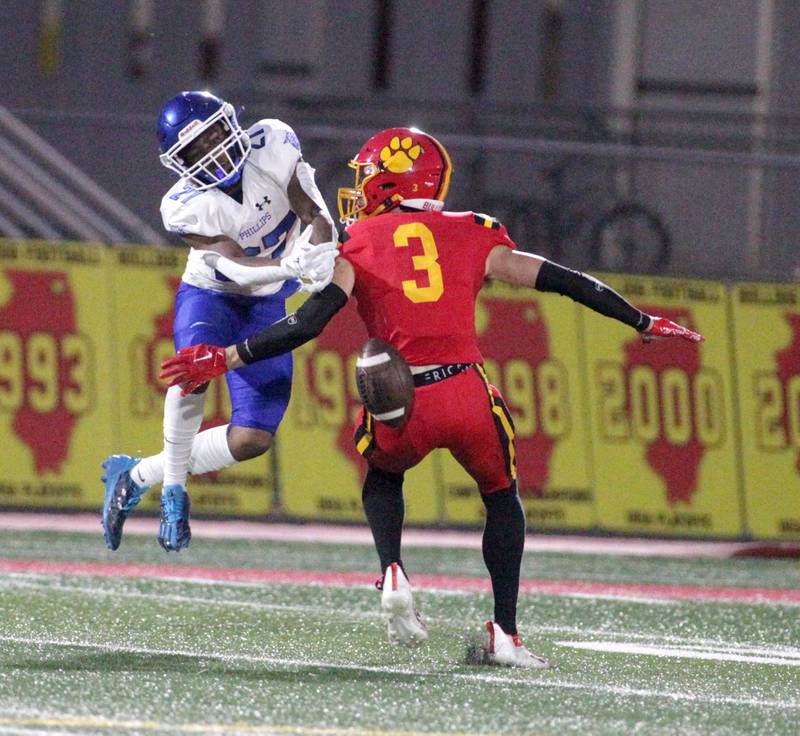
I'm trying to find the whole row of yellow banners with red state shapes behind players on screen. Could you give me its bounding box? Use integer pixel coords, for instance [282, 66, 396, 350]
[0, 240, 800, 539]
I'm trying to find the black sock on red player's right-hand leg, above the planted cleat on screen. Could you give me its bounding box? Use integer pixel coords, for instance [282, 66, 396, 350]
[481, 485, 525, 635]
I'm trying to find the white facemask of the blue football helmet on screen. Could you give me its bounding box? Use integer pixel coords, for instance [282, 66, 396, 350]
[160, 103, 250, 190]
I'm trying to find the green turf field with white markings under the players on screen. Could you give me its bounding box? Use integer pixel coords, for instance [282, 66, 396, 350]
[0, 525, 800, 736]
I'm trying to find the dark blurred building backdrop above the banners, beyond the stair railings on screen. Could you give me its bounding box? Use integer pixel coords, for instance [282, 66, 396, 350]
[0, 0, 800, 280]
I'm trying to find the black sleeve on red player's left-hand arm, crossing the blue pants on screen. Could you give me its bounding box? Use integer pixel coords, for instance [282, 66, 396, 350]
[236, 284, 347, 363]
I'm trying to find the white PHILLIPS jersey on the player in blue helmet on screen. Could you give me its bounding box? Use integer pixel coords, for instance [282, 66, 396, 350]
[161, 120, 302, 296]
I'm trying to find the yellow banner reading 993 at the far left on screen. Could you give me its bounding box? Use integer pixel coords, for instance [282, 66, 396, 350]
[0, 240, 114, 508]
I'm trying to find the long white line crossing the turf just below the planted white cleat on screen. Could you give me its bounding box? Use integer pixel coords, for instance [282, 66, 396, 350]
[0, 636, 800, 712]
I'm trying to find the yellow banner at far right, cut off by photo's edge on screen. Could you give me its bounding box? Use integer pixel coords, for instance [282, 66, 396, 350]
[733, 284, 800, 539]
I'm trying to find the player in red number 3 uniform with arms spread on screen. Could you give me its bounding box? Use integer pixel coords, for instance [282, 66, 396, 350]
[162, 128, 703, 667]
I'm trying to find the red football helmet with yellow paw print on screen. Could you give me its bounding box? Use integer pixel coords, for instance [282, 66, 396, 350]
[339, 128, 453, 223]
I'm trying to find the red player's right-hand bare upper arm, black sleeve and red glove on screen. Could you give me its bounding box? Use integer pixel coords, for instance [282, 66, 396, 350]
[486, 245, 704, 342]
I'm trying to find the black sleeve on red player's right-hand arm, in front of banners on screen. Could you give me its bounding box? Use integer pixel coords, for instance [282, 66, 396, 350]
[536, 261, 650, 332]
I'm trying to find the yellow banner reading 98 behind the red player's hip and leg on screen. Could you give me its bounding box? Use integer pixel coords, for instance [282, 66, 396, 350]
[441, 283, 594, 529]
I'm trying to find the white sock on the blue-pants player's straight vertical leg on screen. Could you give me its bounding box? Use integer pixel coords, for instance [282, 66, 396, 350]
[164, 386, 206, 487]
